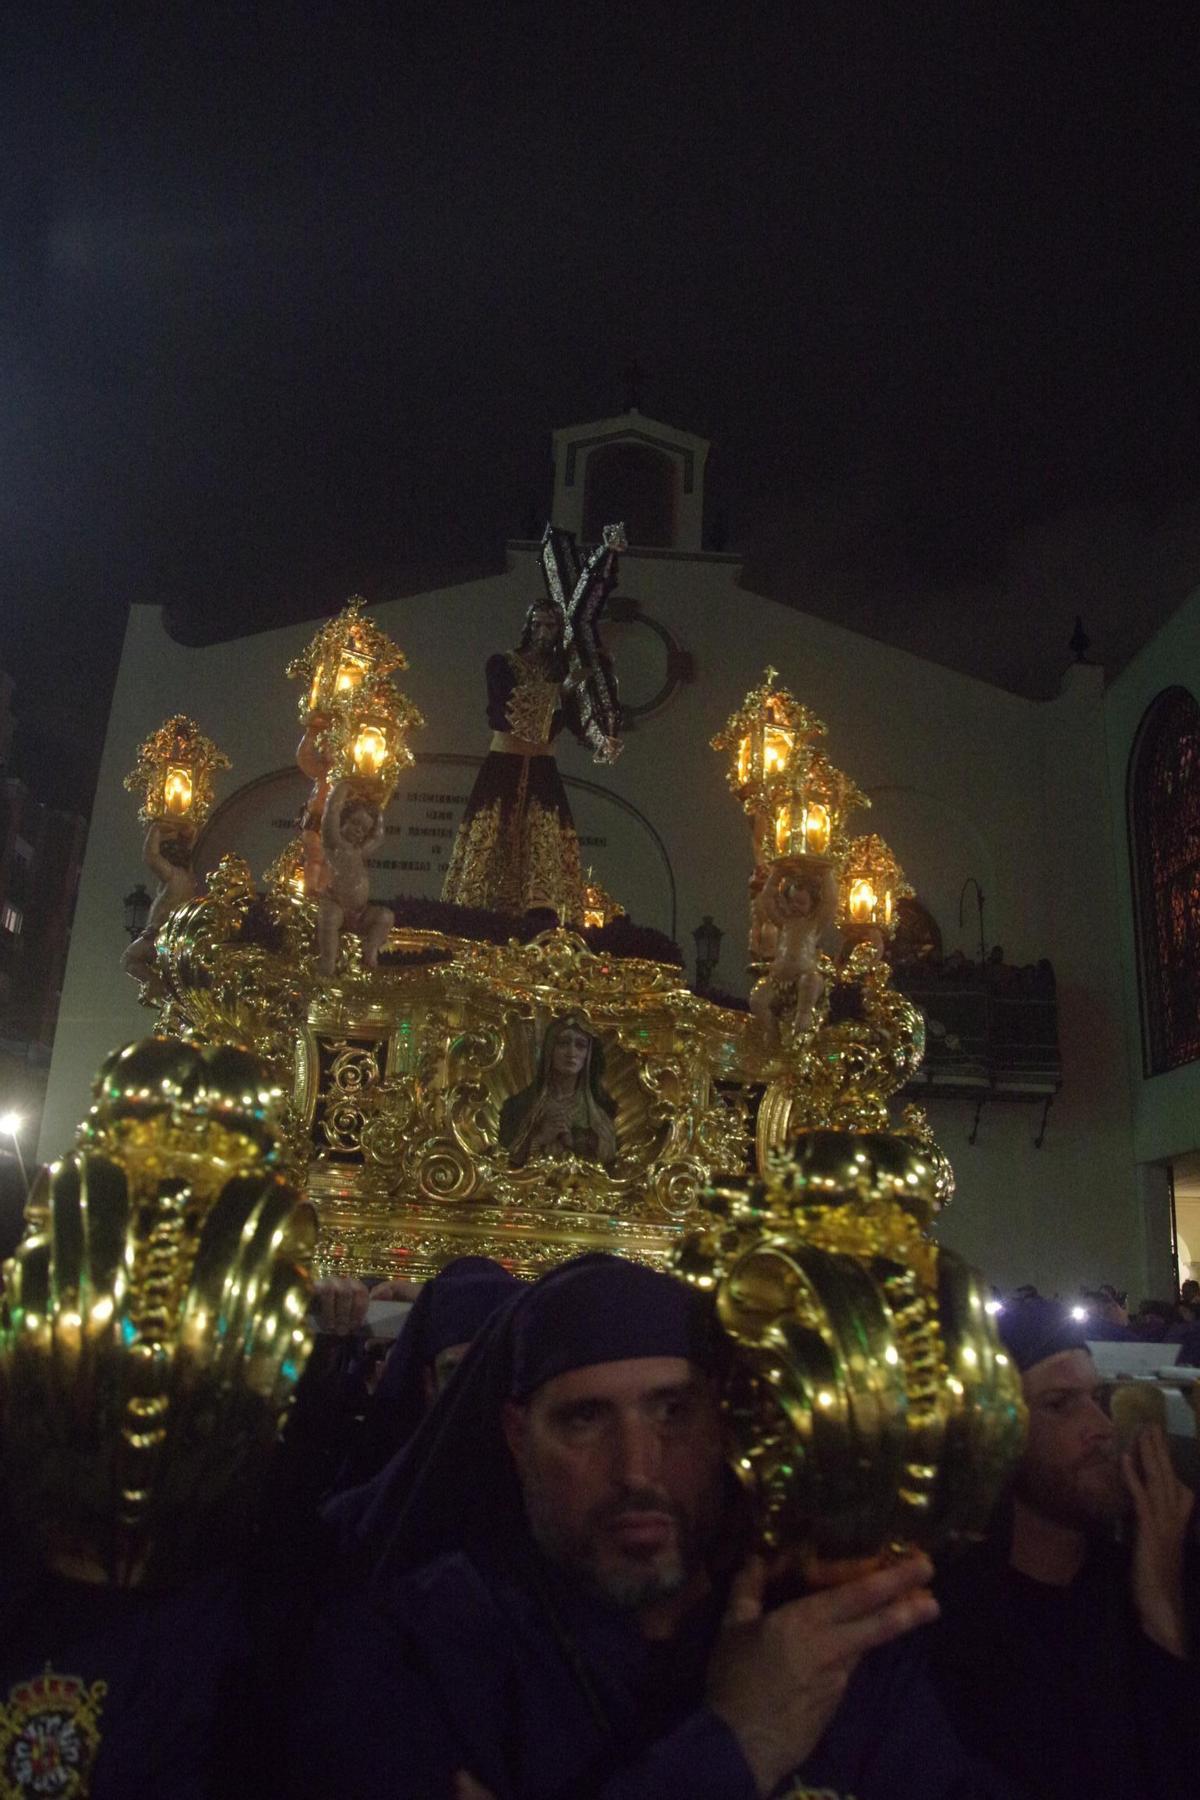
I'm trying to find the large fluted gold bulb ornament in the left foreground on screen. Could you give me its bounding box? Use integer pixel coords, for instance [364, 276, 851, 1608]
[0, 1037, 315, 1586]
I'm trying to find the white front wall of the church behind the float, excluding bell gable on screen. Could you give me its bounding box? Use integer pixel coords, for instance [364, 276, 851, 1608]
[41, 547, 1128, 1310]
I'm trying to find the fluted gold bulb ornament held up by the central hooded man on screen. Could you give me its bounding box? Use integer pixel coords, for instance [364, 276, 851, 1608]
[675, 1129, 1025, 1577]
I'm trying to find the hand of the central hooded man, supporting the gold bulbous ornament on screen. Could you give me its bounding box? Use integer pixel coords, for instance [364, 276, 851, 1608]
[707, 1557, 937, 1795]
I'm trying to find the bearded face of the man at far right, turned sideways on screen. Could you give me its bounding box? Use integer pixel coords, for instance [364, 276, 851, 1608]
[1015, 1350, 1128, 1532]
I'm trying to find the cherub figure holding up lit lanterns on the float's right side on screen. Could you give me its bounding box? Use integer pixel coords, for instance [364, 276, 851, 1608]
[750, 859, 838, 1049]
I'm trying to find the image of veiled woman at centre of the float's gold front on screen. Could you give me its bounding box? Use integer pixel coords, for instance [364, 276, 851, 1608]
[500, 1015, 617, 1168]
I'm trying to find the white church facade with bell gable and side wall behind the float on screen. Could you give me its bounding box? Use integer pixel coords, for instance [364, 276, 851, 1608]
[41, 412, 1200, 1294]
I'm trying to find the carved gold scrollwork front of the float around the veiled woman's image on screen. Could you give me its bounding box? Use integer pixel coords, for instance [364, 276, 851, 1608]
[147, 900, 750, 1274]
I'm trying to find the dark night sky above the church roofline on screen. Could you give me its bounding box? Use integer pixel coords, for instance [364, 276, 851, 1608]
[0, 0, 1200, 806]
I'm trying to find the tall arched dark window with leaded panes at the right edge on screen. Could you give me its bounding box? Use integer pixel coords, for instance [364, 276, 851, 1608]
[1128, 688, 1200, 1075]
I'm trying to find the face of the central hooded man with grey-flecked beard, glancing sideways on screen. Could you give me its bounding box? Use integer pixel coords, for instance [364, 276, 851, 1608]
[504, 1357, 721, 1609]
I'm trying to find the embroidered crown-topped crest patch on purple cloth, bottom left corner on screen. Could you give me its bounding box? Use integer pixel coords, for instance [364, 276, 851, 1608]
[0, 1663, 108, 1800]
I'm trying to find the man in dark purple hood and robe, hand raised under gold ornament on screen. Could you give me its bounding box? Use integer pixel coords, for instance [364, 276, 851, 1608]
[295, 1256, 1007, 1800]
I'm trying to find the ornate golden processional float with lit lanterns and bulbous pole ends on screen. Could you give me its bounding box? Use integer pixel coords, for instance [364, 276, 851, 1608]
[0, 561, 1024, 1561]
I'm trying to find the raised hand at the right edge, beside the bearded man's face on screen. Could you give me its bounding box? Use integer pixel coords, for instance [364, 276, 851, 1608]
[1121, 1426, 1196, 1656]
